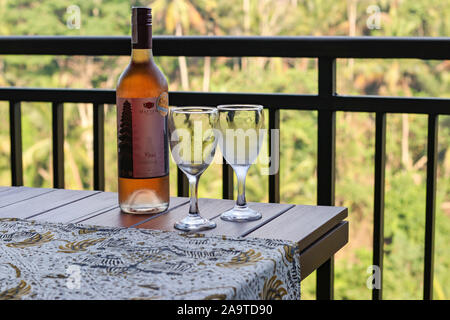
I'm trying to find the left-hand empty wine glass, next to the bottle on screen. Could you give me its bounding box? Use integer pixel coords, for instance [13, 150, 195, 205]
[168, 106, 219, 231]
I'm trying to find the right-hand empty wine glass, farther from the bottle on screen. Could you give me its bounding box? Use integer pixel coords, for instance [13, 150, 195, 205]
[217, 104, 265, 222]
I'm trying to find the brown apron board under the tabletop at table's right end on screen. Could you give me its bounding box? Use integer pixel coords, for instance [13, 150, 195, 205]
[300, 221, 348, 280]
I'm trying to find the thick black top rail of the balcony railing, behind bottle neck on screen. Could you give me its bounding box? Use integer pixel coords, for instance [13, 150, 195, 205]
[0, 36, 450, 60]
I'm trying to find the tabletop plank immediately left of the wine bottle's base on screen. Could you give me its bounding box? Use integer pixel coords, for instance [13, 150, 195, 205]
[33, 192, 119, 223]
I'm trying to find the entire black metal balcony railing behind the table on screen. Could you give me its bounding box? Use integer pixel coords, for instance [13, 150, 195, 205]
[0, 36, 450, 299]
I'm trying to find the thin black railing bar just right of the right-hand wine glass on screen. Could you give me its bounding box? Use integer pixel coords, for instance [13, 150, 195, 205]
[269, 108, 280, 203]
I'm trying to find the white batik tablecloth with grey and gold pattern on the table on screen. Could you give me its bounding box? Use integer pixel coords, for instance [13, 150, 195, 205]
[0, 218, 300, 300]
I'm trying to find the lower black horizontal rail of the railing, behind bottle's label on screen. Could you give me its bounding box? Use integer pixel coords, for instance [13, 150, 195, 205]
[0, 87, 450, 115]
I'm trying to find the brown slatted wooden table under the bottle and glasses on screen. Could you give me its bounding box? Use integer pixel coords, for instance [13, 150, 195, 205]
[0, 187, 348, 279]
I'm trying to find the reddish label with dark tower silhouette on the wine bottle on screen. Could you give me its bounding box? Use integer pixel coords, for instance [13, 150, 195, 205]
[116, 92, 169, 179]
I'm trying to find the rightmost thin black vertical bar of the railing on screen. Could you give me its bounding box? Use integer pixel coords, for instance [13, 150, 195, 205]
[423, 114, 439, 300]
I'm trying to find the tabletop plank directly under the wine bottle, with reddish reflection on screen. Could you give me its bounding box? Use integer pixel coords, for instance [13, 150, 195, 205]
[78, 197, 189, 227]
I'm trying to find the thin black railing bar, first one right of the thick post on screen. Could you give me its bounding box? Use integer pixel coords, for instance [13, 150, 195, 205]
[372, 112, 386, 300]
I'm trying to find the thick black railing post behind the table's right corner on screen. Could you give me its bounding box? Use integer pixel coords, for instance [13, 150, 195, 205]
[316, 57, 336, 300]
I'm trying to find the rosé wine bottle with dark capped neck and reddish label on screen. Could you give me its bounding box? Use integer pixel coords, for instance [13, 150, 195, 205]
[116, 7, 169, 214]
